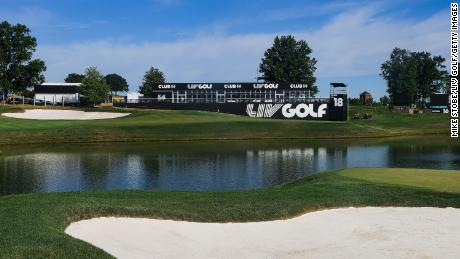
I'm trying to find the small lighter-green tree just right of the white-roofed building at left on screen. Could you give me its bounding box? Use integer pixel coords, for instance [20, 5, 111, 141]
[81, 67, 110, 105]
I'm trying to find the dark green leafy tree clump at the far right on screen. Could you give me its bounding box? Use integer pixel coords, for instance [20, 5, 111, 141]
[381, 48, 447, 105]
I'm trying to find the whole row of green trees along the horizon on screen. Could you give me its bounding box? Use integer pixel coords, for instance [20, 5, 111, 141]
[0, 21, 448, 104]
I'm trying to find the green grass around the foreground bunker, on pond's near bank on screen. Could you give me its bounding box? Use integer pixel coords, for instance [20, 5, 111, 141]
[0, 168, 460, 258]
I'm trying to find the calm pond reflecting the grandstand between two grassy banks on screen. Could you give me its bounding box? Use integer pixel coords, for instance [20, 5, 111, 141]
[0, 137, 460, 194]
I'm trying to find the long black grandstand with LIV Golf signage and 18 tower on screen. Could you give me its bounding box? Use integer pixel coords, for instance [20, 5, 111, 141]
[117, 83, 348, 120]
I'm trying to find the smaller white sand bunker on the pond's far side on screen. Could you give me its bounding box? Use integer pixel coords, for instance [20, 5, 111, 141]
[2, 109, 131, 120]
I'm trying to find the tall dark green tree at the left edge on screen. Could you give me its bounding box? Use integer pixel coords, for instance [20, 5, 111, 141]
[0, 21, 46, 96]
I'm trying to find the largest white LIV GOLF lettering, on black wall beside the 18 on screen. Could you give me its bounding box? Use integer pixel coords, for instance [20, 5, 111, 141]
[250, 103, 328, 119]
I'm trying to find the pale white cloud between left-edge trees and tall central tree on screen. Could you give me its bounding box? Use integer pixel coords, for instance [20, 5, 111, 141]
[36, 35, 272, 86]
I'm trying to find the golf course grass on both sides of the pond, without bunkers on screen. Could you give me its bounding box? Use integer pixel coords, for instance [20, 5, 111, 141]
[0, 106, 460, 258]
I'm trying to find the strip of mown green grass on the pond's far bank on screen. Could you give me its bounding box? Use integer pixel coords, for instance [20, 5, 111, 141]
[0, 105, 449, 144]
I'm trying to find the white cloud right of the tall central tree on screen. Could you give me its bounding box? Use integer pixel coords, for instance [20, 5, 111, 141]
[300, 8, 449, 76]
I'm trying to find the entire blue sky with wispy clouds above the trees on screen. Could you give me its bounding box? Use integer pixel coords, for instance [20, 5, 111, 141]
[0, 0, 450, 97]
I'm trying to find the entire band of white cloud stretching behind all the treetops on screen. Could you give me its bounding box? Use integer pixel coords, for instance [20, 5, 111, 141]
[36, 4, 449, 93]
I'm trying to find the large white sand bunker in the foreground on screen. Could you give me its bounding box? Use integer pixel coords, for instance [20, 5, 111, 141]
[66, 207, 460, 259]
